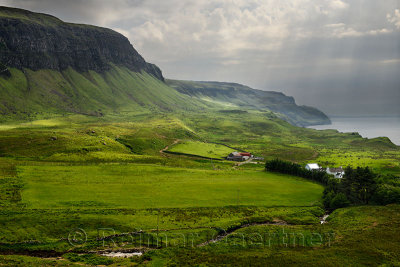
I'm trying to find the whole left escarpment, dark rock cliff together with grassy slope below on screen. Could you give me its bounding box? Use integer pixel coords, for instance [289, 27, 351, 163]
[0, 7, 204, 121]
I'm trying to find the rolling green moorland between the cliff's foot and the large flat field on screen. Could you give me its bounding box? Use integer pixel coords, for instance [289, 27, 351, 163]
[0, 111, 400, 174]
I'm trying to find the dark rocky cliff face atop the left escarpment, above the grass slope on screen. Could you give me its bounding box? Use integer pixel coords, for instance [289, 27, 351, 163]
[0, 7, 163, 80]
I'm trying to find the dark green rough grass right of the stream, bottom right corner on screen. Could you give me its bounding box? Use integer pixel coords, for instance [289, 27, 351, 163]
[159, 205, 400, 266]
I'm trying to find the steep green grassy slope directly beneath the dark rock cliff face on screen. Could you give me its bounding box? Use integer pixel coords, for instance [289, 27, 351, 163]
[0, 66, 210, 121]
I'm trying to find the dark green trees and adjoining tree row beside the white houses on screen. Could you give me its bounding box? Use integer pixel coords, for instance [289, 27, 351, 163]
[265, 159, 400, 210]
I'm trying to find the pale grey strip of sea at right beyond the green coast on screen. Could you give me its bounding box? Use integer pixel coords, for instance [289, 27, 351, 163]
[308, 117, 400, 146]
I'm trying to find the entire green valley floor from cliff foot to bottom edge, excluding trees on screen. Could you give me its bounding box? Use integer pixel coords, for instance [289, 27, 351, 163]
[0, 112, 400, 266]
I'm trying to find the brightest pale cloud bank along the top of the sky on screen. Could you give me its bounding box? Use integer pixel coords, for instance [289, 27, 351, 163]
[101, 0, 393, 61]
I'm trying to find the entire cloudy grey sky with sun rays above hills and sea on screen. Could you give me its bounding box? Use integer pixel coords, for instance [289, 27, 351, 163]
[0, 0, 400, 117]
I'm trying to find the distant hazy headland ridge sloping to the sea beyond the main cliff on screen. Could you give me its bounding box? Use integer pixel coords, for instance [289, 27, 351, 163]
[167, 80, 331, 126]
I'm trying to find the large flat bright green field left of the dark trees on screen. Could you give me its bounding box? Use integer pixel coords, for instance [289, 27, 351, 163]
[19, 164, 323, 209]
